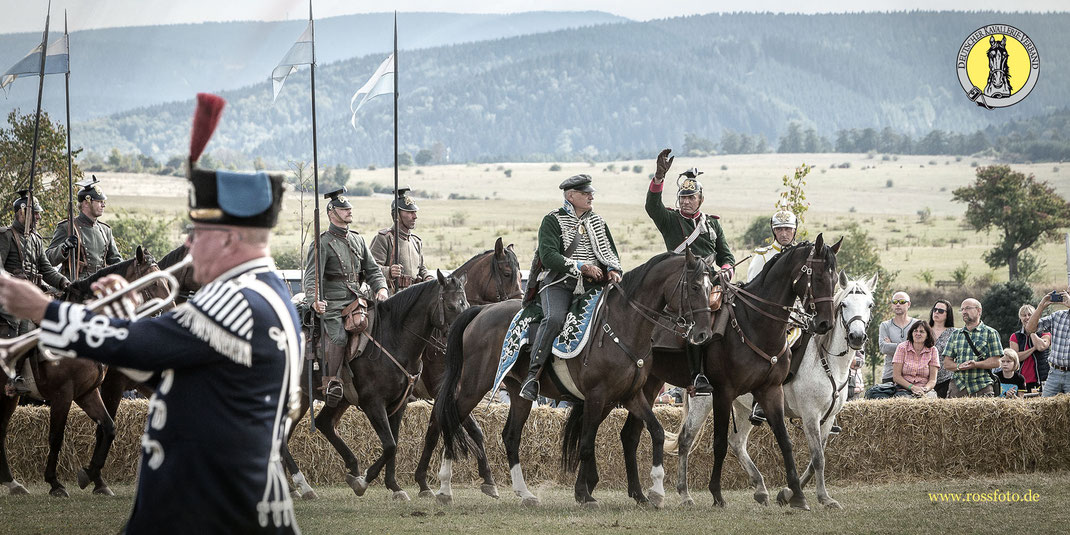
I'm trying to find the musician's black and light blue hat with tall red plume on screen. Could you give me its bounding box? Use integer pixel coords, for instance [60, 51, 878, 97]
[188, 93, 286, 228]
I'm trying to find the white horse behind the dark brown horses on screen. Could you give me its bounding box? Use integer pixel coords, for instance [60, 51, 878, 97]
[664, 271, 877, 508]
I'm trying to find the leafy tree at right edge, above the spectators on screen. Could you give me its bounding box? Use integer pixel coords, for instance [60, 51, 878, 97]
[951, 166, 1070, 280]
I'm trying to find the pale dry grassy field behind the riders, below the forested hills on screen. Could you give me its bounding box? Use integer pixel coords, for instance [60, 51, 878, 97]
[98, 150, 1070, 289]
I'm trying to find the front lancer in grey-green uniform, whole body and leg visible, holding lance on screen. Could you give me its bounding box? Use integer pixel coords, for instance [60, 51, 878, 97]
[302, 187, 388, 407]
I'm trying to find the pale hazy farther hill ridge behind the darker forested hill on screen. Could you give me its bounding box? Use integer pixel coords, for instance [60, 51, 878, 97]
[0, 12, 627, 121]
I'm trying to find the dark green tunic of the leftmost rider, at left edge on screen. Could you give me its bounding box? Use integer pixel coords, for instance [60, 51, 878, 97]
[0, 221, 70, 337]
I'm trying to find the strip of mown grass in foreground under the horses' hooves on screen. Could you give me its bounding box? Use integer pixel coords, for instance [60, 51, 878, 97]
[0, 475, 1070, 534]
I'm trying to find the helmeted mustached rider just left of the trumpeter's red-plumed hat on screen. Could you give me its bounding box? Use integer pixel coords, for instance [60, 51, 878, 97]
[46, 174, 122, 280]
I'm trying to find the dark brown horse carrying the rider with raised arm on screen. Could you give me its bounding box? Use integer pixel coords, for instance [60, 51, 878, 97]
[621, 234, 842, 509]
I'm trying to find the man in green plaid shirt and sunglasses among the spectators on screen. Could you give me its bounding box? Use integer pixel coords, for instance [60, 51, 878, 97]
[944, 297, 1003, 398]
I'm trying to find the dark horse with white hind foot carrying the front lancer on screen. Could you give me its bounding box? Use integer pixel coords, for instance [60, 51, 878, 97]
[281, 272, 468, 501]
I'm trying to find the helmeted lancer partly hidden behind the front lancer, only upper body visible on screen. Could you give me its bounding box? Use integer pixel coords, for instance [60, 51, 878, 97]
[371, 187, 434, 294]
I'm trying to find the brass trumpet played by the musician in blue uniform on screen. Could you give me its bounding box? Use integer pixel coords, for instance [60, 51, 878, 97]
[0, 255, 193, 378]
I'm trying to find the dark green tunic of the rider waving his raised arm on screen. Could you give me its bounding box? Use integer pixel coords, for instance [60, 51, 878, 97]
[646, 182, 735, 266]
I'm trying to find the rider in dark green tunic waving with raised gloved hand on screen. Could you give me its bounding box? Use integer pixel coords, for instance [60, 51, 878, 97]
[646, 149, 735, 396]
